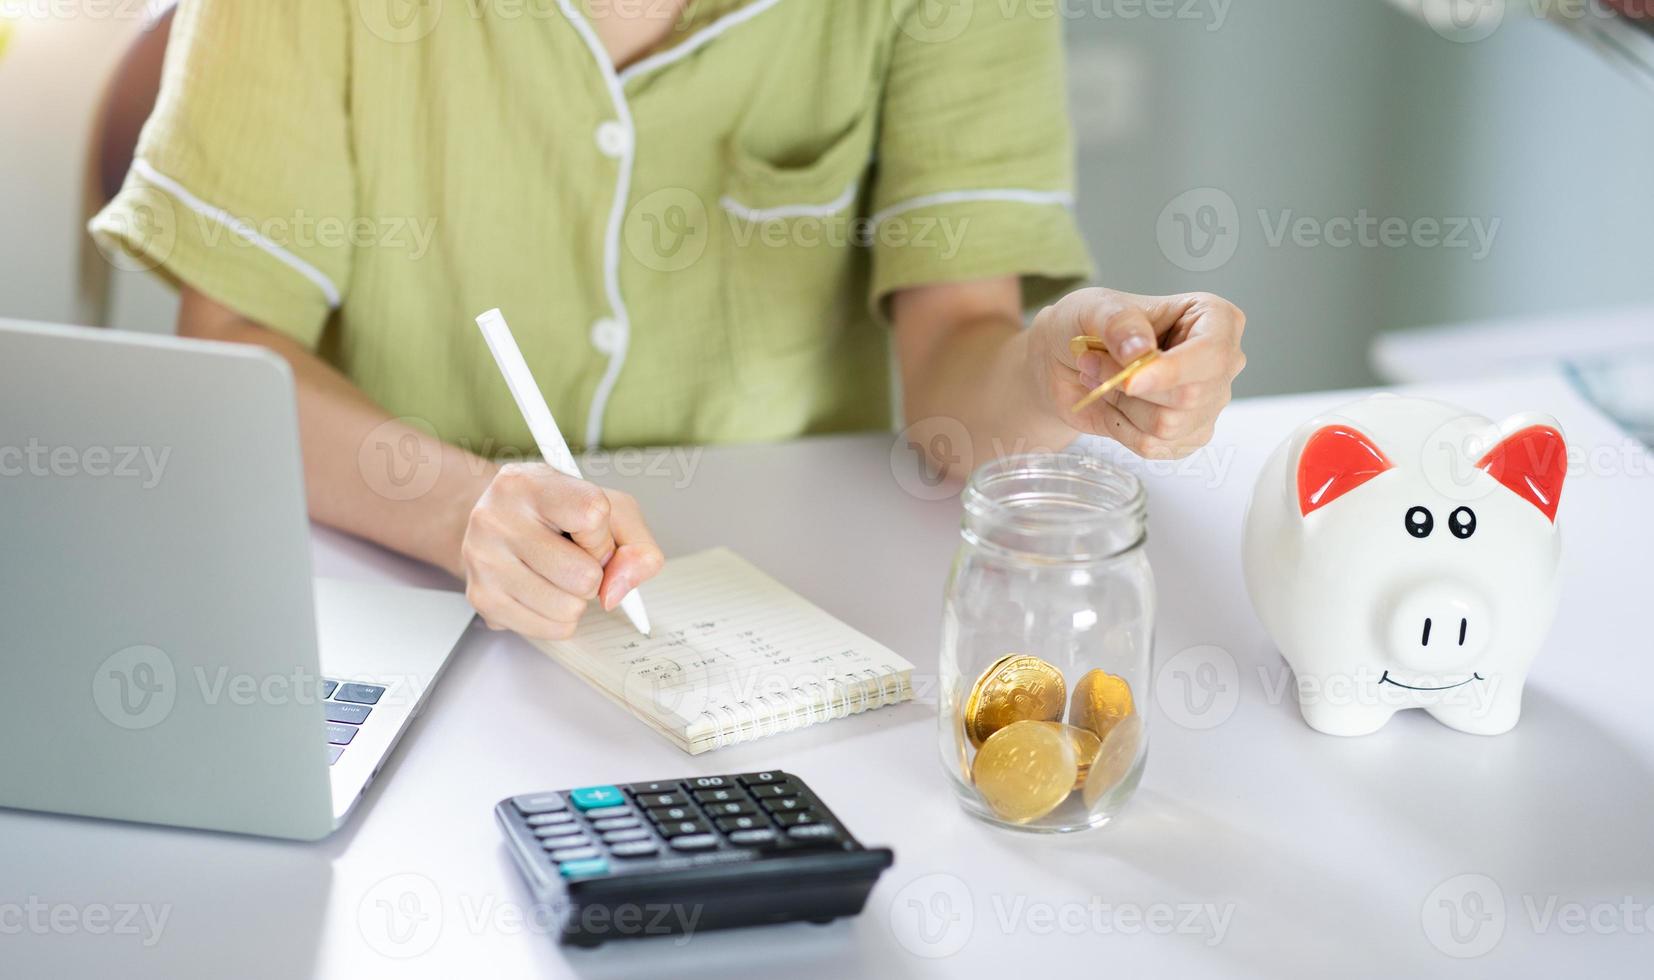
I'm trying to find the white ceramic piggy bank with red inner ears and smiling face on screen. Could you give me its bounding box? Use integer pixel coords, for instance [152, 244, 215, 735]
[1242, 395, 1566, 735]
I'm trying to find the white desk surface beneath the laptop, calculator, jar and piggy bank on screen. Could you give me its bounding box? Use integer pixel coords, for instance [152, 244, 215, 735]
[0, 371, 1654, 980]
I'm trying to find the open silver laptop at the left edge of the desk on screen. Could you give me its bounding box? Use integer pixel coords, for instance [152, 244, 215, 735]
[0, 321, 473, 840]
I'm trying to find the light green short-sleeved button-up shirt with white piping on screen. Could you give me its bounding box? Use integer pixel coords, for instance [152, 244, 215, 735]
[91, 0, 1090, 456]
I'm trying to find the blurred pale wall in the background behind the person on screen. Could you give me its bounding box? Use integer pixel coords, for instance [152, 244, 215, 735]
[0, 0, 1654, 393]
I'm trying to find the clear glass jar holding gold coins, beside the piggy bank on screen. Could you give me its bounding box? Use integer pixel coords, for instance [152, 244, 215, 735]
[938, 453, 1154, 833]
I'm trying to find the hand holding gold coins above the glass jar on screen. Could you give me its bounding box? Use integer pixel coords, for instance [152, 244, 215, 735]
[1029, 288, 1245, 459]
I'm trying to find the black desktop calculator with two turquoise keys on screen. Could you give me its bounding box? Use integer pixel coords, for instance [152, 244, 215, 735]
[495, 770, 895, 945]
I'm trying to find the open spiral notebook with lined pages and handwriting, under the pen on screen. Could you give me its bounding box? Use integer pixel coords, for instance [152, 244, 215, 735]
[536, 549, 913, 755]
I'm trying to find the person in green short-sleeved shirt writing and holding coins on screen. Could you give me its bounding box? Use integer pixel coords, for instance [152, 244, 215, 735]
[91, 0, 1244, 638]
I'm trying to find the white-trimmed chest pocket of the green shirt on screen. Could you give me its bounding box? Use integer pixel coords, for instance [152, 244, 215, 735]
[718, 111, 877, 383]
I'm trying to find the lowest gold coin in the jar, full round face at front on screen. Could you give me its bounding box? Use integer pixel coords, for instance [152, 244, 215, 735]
[971, 722, 1078, 823]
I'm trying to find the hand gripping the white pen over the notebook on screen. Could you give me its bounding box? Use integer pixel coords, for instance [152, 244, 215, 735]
[460, 463, 665, 640]
